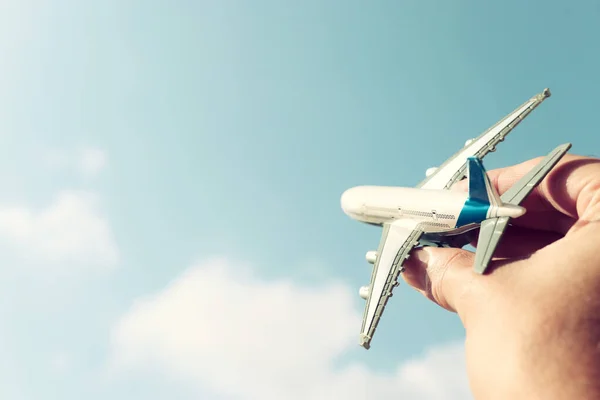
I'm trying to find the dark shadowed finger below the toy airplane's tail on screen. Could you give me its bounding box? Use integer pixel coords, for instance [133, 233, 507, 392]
[471, 225, 564, 259]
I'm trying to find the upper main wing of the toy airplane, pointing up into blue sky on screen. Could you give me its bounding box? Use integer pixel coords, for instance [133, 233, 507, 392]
[417, 89, 550, 189]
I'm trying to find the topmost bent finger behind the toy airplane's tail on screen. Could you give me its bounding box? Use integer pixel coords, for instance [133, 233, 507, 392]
[456, 154, 600, 234]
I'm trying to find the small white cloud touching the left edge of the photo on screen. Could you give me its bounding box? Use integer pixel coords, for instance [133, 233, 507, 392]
[0, 191, 119, 267]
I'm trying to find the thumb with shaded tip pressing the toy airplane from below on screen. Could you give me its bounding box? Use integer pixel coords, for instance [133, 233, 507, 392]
[402, 247, 478, 313]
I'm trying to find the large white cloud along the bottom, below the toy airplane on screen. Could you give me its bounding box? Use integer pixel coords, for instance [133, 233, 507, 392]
[111, 260, 470, 400]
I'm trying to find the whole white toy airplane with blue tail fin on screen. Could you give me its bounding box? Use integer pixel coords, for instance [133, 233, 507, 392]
[341, 89, 571, 349]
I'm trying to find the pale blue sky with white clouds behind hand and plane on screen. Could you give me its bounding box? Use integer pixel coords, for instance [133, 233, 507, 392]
[0, 0, 600, 400]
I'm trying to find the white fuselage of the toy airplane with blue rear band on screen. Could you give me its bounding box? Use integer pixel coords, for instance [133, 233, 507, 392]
[341, 186, 525, 233]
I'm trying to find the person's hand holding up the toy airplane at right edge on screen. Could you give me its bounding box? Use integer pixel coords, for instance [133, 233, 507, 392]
[403, 155, 600, 400]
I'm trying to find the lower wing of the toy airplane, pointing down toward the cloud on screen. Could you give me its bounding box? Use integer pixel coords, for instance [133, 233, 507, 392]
[360, 219, 423, 349]
